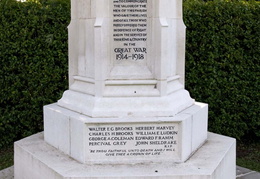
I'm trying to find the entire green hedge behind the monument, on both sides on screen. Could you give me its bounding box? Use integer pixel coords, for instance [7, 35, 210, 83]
[0, 0, 260, 147]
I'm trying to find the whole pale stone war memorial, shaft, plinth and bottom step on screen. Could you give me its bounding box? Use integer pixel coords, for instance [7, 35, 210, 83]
[15, 0, 235, 179]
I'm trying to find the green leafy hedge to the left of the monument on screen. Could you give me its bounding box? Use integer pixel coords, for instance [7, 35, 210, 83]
[0, 0, 70, 147]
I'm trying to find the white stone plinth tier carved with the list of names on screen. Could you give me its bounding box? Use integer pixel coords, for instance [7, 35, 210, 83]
[44, 103, 208, 164]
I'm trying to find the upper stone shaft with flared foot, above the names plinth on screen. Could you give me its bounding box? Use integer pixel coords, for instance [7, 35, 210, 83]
[58, 0, 194, 118]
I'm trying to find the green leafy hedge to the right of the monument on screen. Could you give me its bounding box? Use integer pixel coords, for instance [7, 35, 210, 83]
[184, 0, 260, 140]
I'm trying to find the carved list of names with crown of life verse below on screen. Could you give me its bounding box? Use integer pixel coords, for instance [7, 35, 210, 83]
[87, 123, 179, 158]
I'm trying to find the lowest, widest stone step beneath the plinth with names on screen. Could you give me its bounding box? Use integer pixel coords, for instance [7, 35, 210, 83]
[14, 132, 236, 179]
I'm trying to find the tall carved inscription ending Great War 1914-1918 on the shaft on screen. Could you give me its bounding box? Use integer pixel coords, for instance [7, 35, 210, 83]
[112, 0, 147, 61]
